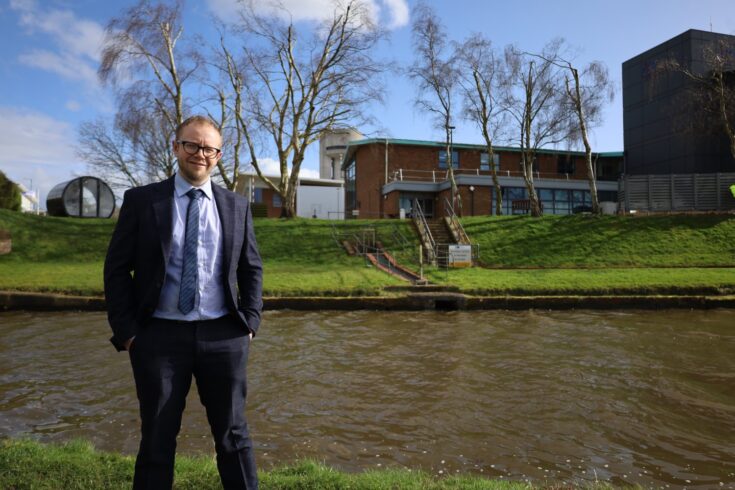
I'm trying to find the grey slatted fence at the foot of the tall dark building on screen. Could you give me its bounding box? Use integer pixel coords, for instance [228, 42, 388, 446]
[618, 173, 735, 212]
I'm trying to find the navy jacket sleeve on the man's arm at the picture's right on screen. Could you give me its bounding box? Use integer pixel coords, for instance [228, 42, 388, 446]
[237, 201, 263, 336]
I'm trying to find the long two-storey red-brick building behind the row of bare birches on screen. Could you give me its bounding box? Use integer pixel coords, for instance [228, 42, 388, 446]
[342, 139, 623, 218]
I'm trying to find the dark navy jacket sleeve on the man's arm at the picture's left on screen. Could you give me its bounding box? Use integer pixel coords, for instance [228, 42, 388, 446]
[104, 190, 139, 351]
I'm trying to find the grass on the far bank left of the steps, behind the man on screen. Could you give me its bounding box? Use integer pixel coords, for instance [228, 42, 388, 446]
[0, 210, 418, 296]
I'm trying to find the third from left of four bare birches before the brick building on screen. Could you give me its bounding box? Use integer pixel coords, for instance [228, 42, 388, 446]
[502, 40, 573, 217]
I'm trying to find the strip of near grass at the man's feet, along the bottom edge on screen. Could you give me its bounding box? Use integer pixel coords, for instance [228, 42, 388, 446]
[0, 440, 628, 490]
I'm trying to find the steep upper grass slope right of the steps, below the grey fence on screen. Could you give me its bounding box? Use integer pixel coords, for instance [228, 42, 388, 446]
[462, 214, 735, 268]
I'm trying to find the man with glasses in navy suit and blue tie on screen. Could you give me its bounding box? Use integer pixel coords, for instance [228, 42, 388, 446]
[104, 116, 262, 489]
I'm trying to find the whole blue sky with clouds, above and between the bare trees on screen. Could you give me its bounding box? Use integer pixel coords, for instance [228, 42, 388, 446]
[0, 0, 735, 208]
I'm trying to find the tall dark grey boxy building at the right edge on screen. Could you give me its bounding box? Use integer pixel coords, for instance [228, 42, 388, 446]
[623, 29, 735, 175]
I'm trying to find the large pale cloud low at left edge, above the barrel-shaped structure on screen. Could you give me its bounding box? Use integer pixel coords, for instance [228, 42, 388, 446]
[0, 107, 86, 209]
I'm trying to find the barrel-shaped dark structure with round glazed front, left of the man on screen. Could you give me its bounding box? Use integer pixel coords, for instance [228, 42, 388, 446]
[46, 177, 115, 218]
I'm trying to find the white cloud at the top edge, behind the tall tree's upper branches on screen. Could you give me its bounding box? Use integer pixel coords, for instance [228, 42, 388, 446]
[207, 0, 408, 28]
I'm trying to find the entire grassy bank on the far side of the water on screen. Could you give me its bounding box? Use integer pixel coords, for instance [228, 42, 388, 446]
[0, 210, 735, 296]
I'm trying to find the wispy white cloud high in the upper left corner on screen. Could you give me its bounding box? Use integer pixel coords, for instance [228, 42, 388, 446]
[10, 0, 105, 87]
